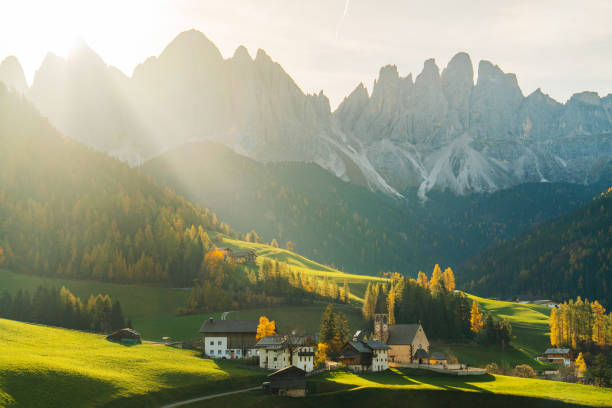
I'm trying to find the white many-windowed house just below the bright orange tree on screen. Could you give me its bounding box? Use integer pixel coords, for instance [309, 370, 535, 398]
[255, 335, 316, 372]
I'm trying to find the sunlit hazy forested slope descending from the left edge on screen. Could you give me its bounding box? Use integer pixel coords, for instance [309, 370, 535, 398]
[0, 84, 232, 285]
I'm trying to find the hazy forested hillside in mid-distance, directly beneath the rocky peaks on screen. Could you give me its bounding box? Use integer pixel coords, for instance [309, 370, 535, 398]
[142, 142, 600, 276]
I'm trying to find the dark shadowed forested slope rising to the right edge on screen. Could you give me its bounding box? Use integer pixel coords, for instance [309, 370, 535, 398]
[461, 190, 612, 306]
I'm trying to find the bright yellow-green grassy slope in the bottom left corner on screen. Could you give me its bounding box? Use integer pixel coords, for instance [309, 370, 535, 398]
[0, 319, 263, 407]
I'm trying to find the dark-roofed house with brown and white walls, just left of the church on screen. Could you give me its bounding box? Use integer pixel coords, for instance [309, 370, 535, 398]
[340, 340, 389, 372]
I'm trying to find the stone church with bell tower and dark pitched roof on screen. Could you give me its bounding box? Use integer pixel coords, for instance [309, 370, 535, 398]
[374, 314, 429, 364]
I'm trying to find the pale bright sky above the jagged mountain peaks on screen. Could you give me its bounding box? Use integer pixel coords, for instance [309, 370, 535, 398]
[0, 0, 612, 106]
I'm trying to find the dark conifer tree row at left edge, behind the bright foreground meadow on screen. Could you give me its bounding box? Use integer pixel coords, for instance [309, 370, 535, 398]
[0, 286, 126, 333]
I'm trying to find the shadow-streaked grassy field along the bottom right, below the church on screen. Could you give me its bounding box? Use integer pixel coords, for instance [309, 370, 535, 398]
[190, 369, 612, 408]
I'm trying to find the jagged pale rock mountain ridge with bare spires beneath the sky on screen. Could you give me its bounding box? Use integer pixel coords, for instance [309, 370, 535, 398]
[0, 30, 612, 198]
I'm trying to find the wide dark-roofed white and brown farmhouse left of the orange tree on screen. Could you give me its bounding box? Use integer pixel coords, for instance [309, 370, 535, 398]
[200, 317, 259, 359]
